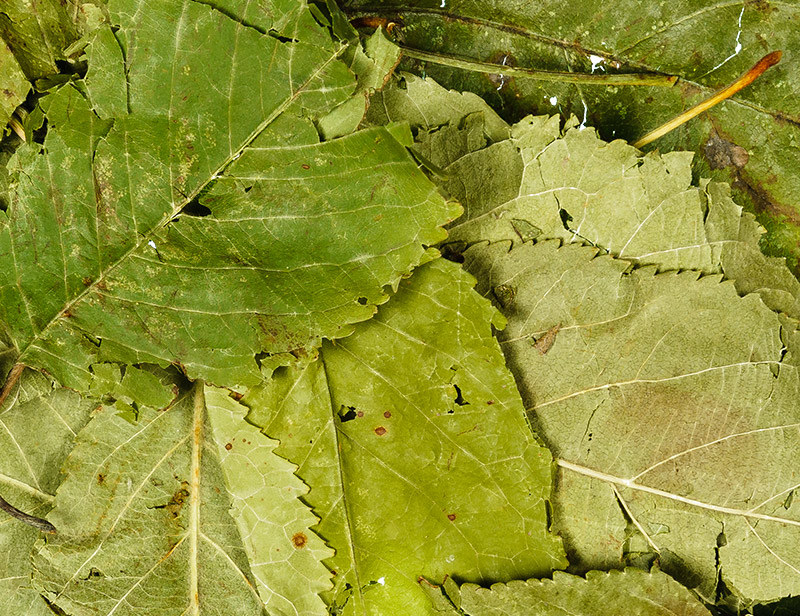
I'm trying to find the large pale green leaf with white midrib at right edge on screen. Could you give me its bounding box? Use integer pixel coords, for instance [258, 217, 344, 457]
[465, 242, 800, 601]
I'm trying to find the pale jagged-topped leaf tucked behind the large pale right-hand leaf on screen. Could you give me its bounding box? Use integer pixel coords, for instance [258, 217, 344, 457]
[376, 83, 800, 318]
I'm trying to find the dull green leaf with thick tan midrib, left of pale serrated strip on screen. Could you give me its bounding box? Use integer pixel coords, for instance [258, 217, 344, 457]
[34, 384, 294, 616]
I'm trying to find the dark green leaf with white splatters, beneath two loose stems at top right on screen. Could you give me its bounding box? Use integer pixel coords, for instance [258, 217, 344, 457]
[343, 0, 800, 271]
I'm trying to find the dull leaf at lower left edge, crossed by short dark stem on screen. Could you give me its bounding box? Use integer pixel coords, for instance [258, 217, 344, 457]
[0, 371, 97, 616]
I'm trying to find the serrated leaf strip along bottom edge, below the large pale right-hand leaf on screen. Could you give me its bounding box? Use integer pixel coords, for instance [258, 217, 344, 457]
[438, 568, 710, 616]
